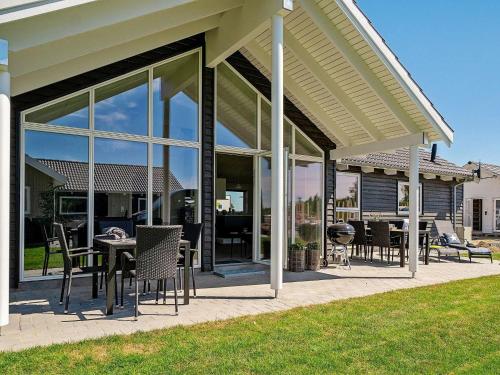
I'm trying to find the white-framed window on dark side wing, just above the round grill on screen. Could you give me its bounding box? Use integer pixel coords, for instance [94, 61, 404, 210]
[335, 172, 360, 222]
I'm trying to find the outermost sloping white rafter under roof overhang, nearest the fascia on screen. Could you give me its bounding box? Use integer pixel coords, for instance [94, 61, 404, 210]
[300, 0, 419, 137]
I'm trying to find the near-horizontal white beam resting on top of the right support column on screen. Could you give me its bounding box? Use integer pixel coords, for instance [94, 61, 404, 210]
[330, 132, 429, 160]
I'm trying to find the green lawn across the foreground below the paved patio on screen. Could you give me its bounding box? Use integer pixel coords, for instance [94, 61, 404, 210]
[0, 276, 500, 374]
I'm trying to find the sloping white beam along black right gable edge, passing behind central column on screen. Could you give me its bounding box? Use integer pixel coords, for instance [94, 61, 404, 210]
[245, 41, 352, 147]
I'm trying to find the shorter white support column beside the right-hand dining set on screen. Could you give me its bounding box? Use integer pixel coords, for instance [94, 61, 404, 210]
[408, 146, 420, 277]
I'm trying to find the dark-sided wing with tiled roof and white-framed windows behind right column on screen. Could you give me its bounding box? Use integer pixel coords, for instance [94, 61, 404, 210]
[336, 149, 472, 232]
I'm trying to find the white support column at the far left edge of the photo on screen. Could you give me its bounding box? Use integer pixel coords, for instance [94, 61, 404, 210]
[0, 40, 10, 329]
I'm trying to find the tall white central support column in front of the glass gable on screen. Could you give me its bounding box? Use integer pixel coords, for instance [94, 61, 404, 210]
[271, 14, 285, 297]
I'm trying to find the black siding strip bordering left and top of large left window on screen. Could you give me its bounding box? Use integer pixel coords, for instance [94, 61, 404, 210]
[10, 34, 204, 287]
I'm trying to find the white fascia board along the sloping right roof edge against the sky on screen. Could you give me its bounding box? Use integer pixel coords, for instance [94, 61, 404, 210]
[336, 0, 453, 146]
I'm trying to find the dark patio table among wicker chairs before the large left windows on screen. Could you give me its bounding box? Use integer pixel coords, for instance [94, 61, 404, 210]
[93, 238, 191, 315]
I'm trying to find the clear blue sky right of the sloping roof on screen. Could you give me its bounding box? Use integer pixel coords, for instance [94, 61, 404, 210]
[357, 0, 500, 165]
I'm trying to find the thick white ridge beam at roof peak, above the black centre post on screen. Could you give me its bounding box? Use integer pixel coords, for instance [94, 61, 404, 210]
[205, 0, 289, 68]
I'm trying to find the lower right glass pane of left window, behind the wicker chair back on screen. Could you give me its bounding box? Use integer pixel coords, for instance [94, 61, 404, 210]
[153, 145, 199, 225]
